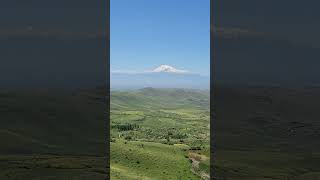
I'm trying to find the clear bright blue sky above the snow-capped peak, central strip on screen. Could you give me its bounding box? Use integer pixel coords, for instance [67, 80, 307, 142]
[110, 0, 210, 75]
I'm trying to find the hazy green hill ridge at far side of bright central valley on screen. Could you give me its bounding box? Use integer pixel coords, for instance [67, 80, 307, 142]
[111, 88, 210, 109]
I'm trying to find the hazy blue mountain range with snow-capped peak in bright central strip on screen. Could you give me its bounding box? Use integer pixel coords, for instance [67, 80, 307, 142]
[110, 65, 210, 89]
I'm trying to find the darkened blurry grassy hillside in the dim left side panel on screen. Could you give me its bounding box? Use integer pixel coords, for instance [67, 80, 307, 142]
[0, 89, 107, 179]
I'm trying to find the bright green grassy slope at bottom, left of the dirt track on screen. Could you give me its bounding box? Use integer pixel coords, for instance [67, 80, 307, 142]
[111, 140, 199, 179]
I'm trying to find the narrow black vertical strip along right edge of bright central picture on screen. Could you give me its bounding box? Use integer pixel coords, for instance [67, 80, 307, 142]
[210, 0, 216, 179]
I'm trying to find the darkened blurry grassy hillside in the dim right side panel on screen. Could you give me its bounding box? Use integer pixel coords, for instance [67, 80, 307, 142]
[214, 85, 320, 180]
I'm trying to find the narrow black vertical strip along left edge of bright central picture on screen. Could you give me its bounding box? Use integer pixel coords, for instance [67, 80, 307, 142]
[103, 0, 110, 180]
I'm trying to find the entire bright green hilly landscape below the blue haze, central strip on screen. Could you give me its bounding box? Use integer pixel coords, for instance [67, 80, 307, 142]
[110, 88, 210, 179]
